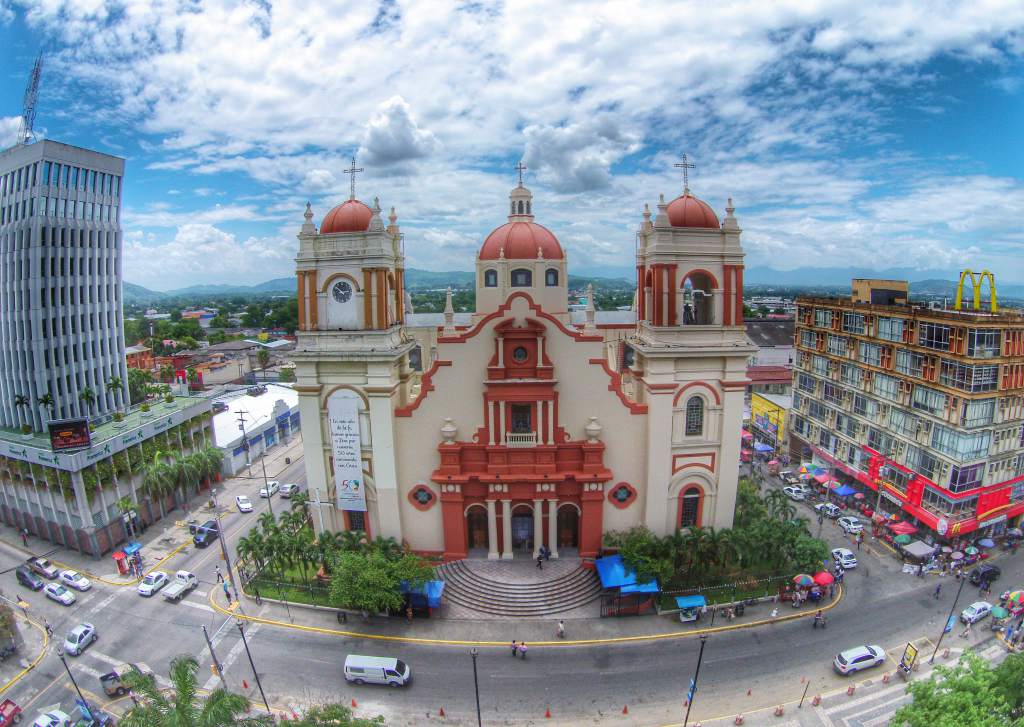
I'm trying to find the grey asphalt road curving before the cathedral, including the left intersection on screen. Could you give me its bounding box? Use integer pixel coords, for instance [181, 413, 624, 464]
[0, 462, 1024, 724]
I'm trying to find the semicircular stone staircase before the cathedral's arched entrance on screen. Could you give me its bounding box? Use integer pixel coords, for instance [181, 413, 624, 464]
[436, 558, 601, 618]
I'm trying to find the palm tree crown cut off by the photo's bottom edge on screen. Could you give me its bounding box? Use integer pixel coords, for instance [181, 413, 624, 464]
[119, 654, 270, 727]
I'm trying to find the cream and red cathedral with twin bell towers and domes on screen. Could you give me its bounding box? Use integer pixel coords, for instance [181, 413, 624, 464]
[295, 161, 754, 561]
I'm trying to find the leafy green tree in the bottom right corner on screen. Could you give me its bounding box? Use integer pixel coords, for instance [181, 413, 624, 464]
[890, 651, 1024, 727]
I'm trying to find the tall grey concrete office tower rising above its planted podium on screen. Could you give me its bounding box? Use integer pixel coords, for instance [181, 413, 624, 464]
[0, 140, 128, 431]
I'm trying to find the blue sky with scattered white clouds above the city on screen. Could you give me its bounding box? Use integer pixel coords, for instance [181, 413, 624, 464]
[0, 0, 1024, 290]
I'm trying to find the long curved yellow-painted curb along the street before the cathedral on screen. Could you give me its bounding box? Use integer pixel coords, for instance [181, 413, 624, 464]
[207, 584, 844, 648]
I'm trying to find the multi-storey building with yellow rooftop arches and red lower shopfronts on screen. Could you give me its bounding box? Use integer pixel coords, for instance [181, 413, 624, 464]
[791, 281, 1024, 539]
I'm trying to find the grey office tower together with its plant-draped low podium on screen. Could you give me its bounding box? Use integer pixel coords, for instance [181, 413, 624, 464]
[0, 139, 210, 555]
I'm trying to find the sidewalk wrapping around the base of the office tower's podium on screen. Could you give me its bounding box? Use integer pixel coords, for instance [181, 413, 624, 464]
[0, 433, 302, 586]
